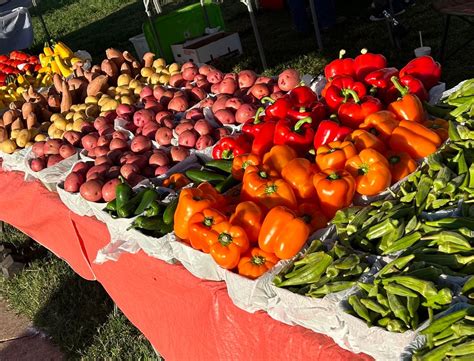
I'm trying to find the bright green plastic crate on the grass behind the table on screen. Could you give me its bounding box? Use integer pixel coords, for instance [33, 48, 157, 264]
[143, 0, 225, 62]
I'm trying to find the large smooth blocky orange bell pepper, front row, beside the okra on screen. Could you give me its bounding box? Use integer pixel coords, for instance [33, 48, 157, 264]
[258, 206, 311, 259]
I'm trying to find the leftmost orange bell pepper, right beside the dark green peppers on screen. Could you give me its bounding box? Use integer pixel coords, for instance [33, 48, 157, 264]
[174, 183, 222, 240]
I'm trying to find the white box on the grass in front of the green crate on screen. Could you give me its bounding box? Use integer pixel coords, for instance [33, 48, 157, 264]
[171, 31, 242, 63]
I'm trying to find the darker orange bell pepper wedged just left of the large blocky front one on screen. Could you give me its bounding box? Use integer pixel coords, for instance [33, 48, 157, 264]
[230, 201, 264, 243]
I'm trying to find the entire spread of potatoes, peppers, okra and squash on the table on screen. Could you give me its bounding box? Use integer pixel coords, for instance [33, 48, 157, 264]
[0, 38, 474, 360]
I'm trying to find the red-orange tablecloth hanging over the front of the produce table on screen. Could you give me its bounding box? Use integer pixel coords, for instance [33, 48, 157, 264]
[0, 170, 370, 360]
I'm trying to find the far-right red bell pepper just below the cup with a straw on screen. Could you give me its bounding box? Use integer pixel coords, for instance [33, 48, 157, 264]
[400, 55, 441, 91]
